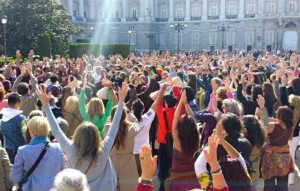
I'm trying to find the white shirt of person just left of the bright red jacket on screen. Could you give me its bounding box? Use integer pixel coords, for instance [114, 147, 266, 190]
[133, 108, 155, 154]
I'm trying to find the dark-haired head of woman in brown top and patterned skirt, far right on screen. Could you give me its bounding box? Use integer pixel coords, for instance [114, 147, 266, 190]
[276, 106, 295, 128]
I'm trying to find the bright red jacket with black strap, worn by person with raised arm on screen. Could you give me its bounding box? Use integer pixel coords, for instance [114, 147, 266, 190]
[156, 86, 184, 144]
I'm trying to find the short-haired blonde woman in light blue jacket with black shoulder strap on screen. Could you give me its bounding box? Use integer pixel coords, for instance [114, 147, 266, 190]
[10, 116, 64, 191]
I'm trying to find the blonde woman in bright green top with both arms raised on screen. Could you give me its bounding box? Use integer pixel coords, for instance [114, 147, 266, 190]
[79, 75, 117, 139]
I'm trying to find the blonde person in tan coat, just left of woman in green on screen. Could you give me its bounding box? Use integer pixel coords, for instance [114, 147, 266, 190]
[62, 96, 83, 138]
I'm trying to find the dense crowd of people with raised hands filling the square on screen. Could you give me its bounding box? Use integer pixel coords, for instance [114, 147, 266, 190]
[0, 50, 300, 191]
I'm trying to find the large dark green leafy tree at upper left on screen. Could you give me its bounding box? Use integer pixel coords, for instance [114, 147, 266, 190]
[0, 0, 84, 55]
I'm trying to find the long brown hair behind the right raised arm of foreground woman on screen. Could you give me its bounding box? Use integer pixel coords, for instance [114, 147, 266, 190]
[111, 106, 130, 149]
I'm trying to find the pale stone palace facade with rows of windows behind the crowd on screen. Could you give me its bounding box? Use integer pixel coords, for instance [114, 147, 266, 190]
[59, 0, 300, 51]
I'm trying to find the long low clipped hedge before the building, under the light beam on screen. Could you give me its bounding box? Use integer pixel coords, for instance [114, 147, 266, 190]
[69, 43, 130, 58]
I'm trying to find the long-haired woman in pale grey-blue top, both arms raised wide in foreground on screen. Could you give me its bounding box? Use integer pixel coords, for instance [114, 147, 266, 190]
[38, 83, 128, 190]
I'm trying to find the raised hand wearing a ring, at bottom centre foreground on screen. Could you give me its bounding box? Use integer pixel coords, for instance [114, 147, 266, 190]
[139, 145, 157, 181]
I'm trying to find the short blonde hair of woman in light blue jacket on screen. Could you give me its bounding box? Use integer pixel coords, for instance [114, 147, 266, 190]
[27, 116, 50, 137]
